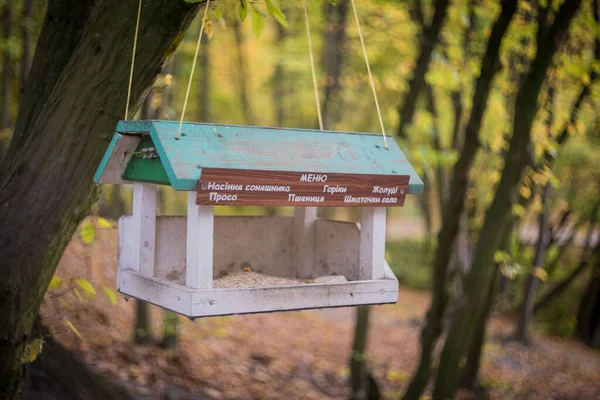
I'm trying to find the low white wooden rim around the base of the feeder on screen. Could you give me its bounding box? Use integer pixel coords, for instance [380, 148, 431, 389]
[119, 269, 398, 317]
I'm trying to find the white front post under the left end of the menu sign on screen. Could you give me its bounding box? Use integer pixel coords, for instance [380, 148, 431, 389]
[185, 192, 215, 289]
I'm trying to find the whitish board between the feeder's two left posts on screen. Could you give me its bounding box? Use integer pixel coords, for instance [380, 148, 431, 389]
[154, 217, 187, 285]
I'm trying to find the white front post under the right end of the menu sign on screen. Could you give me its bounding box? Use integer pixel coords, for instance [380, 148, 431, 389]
[358, 207, 386, 280]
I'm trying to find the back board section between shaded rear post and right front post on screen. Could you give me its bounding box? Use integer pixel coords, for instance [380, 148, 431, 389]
[311, 219, 360, 281]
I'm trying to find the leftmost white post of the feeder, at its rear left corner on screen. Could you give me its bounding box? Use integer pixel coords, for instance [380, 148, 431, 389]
[132, 182, 156, 276]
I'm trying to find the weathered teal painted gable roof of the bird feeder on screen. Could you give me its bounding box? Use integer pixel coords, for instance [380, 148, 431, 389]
[94, 121, 423, 194]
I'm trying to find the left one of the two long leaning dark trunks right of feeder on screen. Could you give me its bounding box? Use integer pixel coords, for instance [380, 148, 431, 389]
[404, 0, 517, 399]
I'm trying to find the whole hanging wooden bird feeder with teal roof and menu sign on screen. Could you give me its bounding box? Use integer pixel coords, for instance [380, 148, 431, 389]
[94, 121, 423, 318]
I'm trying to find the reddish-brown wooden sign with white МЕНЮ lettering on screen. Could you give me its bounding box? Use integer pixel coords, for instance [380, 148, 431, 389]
[196, 168, 410, 207]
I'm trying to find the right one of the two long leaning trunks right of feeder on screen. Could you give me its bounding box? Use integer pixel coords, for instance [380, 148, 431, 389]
[433, 0, 581, 399]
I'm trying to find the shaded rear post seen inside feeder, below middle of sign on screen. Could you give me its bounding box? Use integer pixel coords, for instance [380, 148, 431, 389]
[292, 207, 317, 278]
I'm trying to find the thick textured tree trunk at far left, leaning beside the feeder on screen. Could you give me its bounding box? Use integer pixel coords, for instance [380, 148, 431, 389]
[0, 0, 199, 399]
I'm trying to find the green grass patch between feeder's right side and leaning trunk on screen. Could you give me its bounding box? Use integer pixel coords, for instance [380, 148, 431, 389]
[386, 240, 434, 290]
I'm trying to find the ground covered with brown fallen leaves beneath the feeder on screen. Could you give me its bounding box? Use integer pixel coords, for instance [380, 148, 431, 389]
[42, 221, 600, 399]
